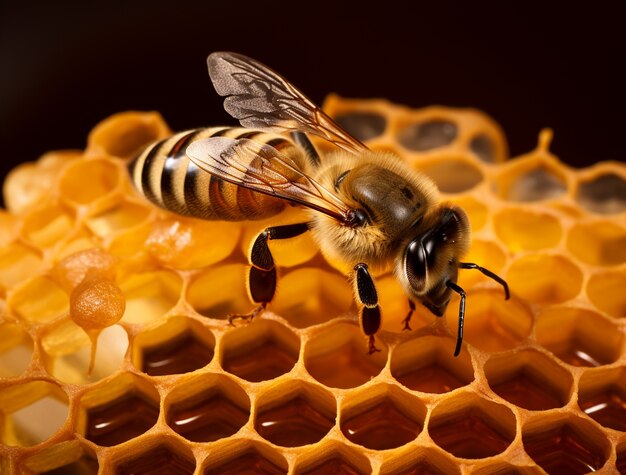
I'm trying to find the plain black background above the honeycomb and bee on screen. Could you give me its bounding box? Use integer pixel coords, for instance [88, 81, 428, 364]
[0, 0, 626, 208]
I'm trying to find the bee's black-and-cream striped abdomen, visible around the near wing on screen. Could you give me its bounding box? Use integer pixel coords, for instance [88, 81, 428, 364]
[128, 127, 293, 221]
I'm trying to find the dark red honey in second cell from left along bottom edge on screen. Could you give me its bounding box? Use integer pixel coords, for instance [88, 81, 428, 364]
[115, 445, 196, 475]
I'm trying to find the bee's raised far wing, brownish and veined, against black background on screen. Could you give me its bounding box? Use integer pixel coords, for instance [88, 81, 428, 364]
[207, 52, 367, 154]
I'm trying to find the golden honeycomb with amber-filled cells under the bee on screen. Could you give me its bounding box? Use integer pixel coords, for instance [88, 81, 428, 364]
[0, 96, 626, 475]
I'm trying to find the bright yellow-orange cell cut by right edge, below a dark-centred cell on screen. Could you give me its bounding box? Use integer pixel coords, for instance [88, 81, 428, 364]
[567, 221, 626, 266]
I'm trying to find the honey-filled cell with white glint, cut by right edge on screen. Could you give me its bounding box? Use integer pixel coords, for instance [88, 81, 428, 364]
[578, 368, 626, 432]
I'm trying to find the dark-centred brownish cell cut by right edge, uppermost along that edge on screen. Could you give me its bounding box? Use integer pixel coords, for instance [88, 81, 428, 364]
[576, 173, 626, 214]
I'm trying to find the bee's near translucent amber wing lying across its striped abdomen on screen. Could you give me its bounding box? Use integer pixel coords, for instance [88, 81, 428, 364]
[187, 137, 354, 224]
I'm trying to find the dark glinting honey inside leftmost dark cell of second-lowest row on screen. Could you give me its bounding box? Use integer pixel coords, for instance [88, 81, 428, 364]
[85, 392, 159, 447]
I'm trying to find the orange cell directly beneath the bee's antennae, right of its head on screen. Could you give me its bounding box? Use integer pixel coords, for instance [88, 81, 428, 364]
[458, 282, 533, 351]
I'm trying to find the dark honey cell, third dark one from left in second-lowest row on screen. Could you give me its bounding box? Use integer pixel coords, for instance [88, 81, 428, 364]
[254, 380, 337, 447]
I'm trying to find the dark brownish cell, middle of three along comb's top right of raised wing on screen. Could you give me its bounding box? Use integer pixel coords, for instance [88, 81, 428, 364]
[397, 119, 458, 152]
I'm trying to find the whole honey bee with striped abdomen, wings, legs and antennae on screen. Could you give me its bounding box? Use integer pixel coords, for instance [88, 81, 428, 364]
[129, 52, 509, 356]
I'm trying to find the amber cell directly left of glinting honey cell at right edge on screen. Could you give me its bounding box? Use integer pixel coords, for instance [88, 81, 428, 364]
[484, 350, 574, 411]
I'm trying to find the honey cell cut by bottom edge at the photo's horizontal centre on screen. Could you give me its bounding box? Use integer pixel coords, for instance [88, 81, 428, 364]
[293, 442, 372, 475]
